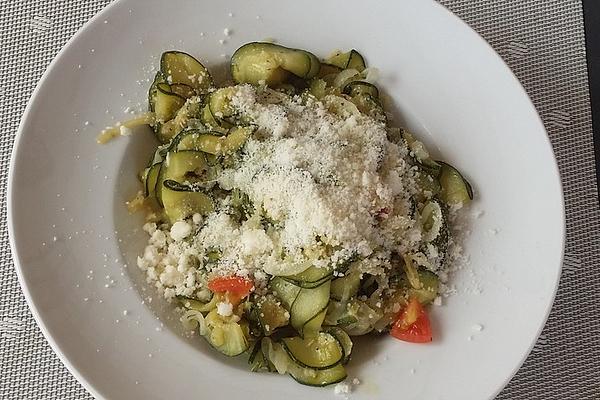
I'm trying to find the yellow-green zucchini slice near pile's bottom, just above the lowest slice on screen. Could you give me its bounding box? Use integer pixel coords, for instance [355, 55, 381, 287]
[281, 332, 344, 370]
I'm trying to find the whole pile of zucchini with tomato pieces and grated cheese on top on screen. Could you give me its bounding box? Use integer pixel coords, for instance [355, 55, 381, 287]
[100, 42, 473, 386]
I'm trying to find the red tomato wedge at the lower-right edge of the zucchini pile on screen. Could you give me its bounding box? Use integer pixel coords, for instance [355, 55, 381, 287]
[390, 297, 432, 343]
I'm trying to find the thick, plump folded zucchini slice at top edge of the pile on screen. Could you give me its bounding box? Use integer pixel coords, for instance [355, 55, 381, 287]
[231, 42, 320, 86]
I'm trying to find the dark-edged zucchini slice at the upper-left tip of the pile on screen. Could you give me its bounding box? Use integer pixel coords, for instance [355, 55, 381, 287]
[160, 51, 213, 94]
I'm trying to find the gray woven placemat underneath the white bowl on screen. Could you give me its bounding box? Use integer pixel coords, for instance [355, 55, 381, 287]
[0, 0, 600, 400]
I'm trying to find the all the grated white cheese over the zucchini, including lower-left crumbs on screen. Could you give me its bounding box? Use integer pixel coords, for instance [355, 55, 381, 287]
[138, 85, 462, 306]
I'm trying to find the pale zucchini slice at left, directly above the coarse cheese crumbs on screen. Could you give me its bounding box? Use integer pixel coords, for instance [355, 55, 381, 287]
[161, 180, 214, 223]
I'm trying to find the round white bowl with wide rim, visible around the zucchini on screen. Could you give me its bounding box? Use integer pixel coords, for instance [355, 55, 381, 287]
[9, 0, 564, 400]
